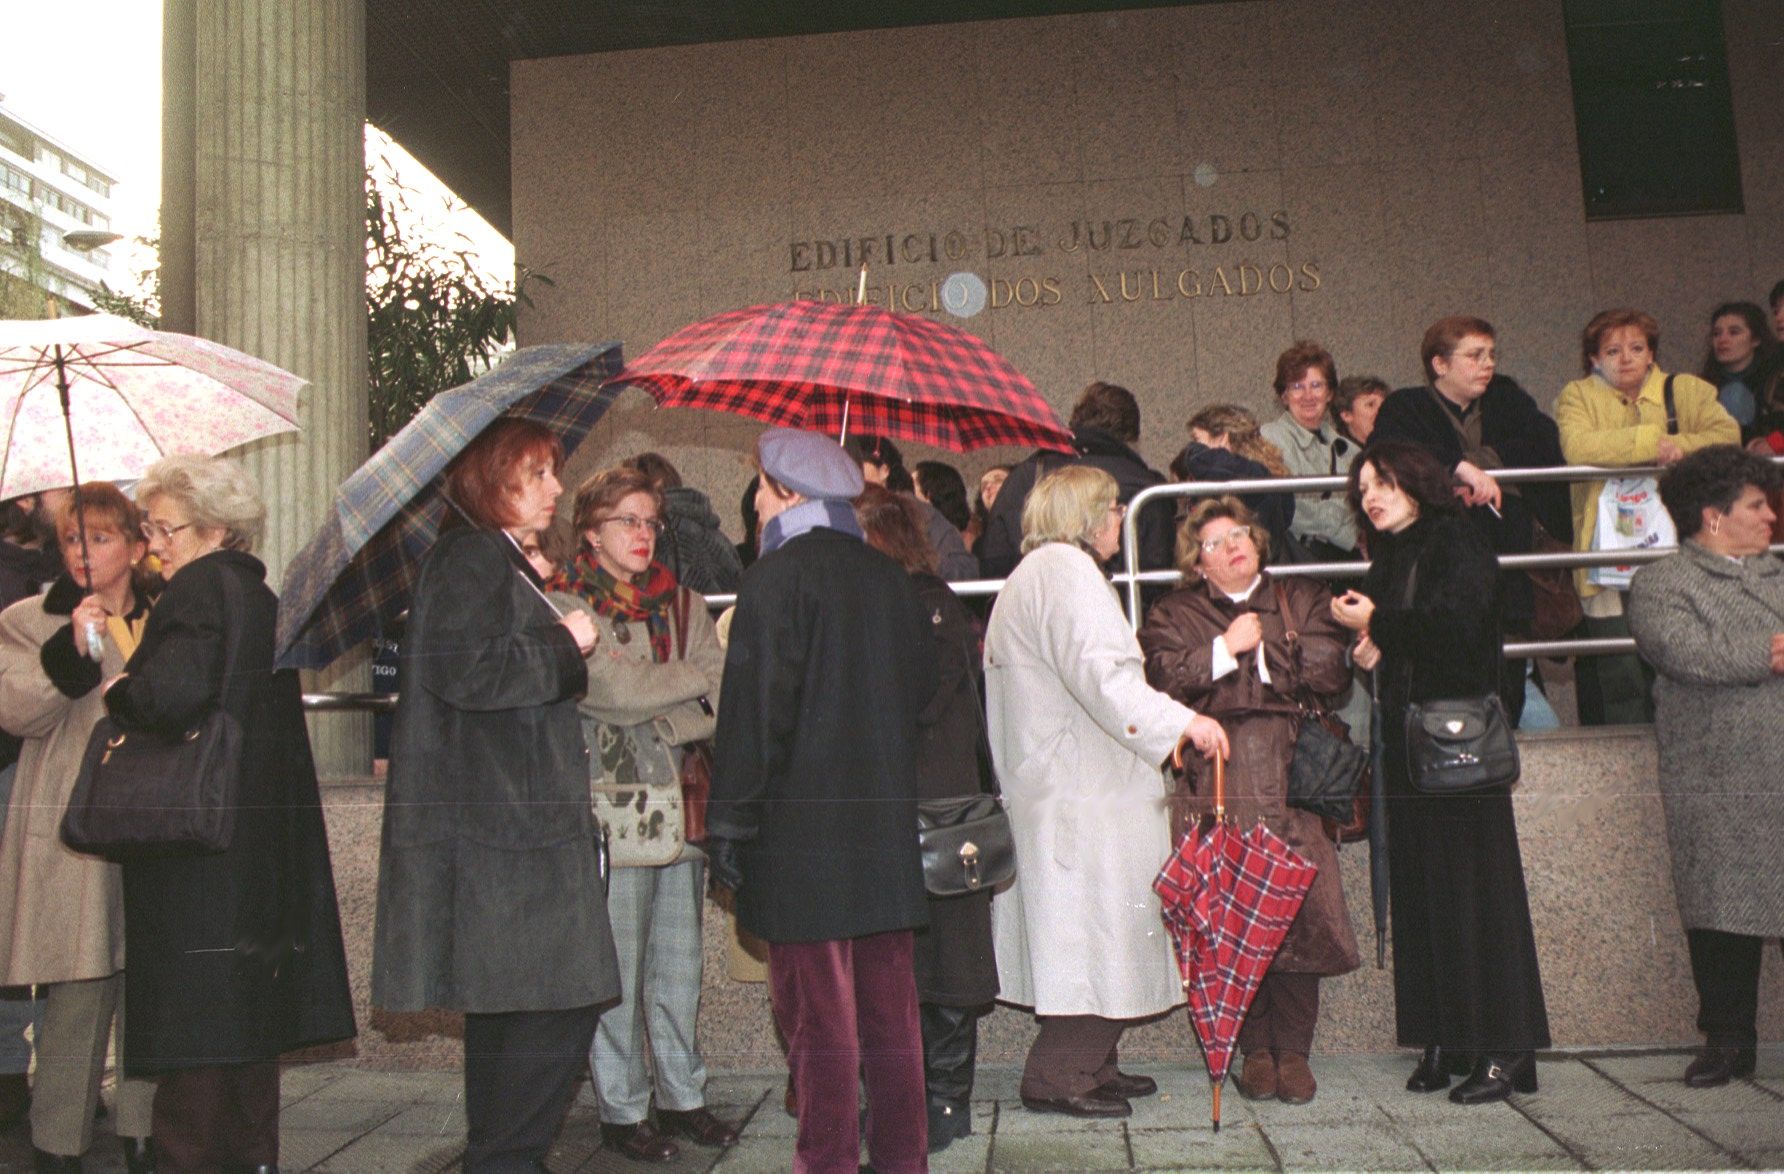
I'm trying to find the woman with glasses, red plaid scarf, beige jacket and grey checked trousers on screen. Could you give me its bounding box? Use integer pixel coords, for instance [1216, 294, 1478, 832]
[551, 466, 737, 1162]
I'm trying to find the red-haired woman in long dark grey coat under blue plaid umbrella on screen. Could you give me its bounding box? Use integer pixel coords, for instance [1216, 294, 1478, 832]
[371, 419, 619, 1174]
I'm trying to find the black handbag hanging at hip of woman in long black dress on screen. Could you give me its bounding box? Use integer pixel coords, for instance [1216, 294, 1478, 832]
[1406, 564, 1522, 796]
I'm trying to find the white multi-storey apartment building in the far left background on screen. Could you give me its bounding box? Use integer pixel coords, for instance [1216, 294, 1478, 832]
[0, 95, 118, 312]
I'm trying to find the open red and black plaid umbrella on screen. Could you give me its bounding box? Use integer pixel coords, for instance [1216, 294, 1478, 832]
[610, 302, 1072, 453]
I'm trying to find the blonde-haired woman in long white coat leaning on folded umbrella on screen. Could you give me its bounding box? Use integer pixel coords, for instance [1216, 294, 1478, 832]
[985, 466, 1227, 1117]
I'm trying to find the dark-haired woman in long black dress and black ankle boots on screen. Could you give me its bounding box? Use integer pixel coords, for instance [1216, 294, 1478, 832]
[1333, 441, 1549, 1104]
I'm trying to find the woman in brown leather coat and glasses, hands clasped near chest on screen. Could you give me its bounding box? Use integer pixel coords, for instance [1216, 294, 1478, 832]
[1140, 498, 1358, 1104]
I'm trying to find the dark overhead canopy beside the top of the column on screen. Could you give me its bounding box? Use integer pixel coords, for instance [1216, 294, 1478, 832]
[366, 0, 1213, 236]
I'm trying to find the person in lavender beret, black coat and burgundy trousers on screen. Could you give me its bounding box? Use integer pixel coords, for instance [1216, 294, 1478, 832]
[706, 428, 937, 1170]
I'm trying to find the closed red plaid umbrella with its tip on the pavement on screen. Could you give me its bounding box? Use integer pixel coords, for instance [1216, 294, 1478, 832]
[1152, 758, 1318, 1133]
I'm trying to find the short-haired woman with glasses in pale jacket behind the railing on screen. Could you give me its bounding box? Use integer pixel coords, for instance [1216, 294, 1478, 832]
[1261, 343, 1356, 562]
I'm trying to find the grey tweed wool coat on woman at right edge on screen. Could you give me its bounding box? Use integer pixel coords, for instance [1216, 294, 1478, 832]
[1629, 541, 1784, 937]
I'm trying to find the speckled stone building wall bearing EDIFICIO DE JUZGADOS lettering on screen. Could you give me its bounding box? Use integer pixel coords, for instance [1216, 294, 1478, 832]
[512, 0, 1784, 525]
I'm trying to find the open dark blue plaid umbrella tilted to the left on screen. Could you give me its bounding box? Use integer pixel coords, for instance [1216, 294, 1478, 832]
[278, 343, 623, 669]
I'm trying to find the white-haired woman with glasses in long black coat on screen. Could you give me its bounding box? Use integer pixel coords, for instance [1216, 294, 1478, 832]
[105, 455, 353, 1174]
